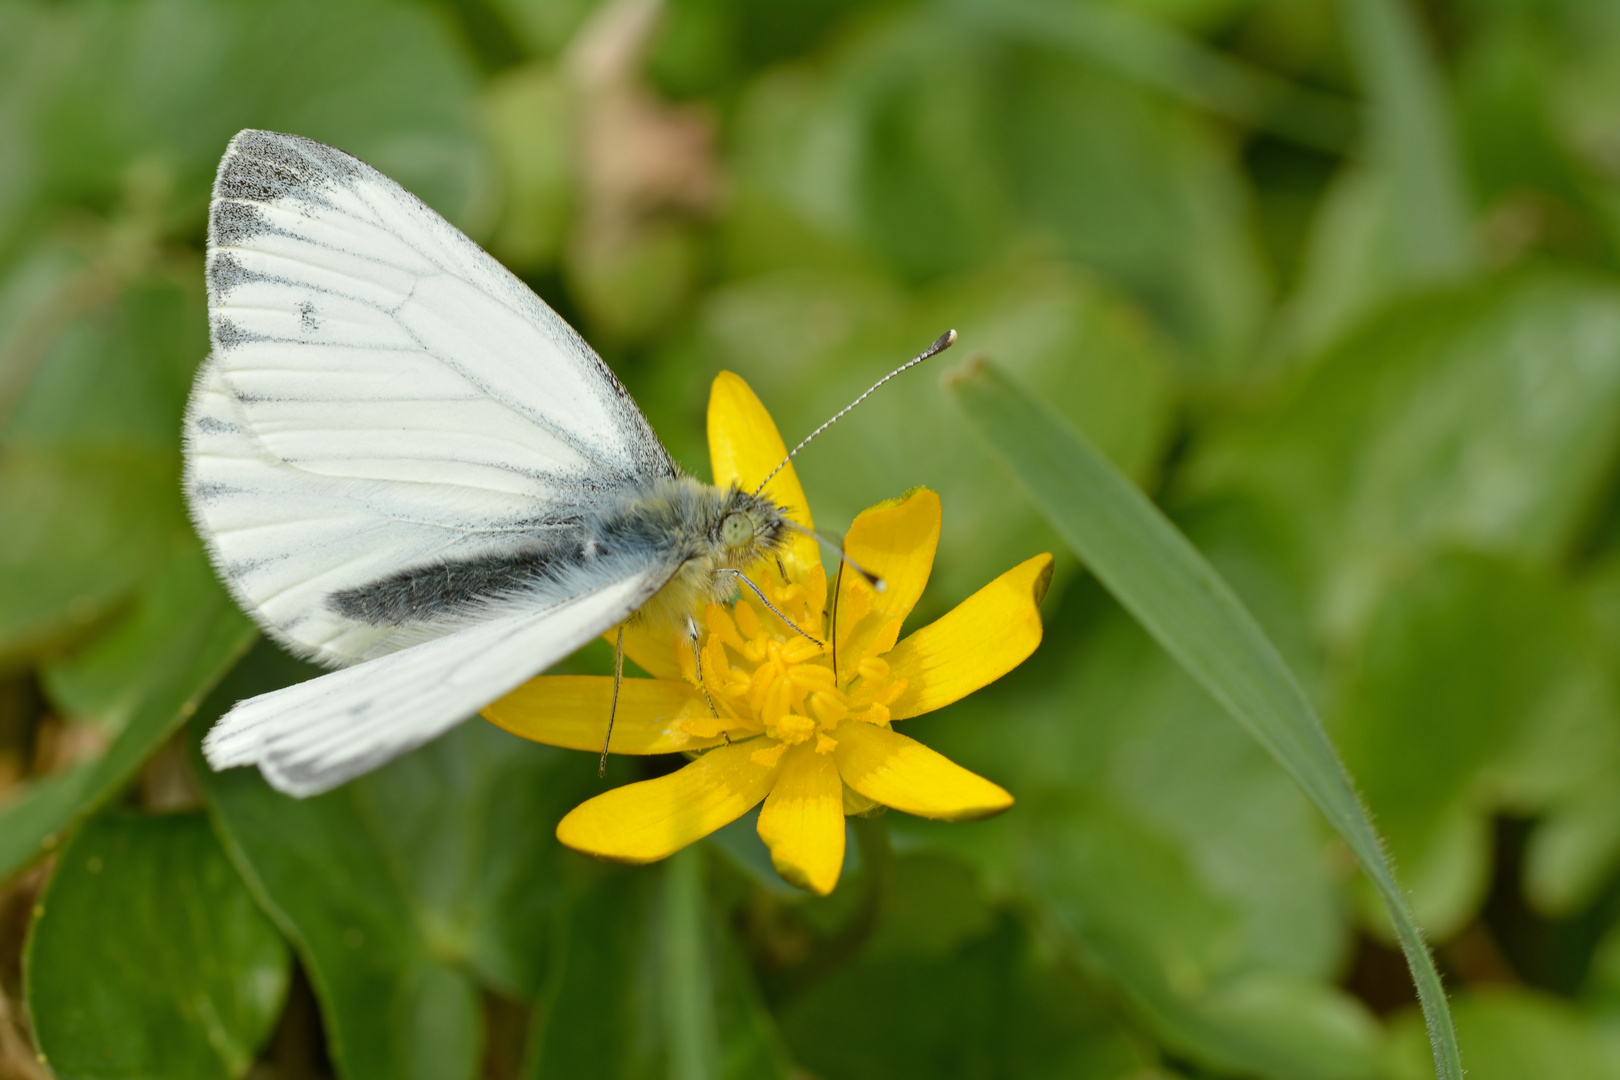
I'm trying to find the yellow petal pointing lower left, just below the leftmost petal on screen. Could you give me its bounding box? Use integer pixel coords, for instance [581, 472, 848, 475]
[557, 740, 781, 863]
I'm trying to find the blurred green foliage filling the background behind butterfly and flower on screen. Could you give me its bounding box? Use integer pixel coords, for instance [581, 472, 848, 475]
[9, 0, 1620, 1080]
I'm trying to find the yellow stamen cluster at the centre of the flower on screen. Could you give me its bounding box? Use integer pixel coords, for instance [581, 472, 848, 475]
[684, 567, 906, 766]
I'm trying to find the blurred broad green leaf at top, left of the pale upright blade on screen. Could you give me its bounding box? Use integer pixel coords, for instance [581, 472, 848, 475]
[985, 52, 1272, 382]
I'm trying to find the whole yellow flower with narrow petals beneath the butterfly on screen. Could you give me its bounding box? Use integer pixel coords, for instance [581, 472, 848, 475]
[484, 372, 1051, 894]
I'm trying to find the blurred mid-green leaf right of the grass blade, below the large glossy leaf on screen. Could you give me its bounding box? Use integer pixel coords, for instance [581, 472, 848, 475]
[1335, 554, 1587, 939]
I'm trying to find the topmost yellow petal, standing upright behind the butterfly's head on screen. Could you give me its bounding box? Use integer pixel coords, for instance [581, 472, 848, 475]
[708, 371, 821, 581]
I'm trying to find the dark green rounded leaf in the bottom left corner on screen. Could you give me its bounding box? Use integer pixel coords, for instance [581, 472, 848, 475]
[28, 813, 290, 1080]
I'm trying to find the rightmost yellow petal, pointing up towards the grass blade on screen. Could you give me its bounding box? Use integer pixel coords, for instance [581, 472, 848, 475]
[883, 555, 1051, 721]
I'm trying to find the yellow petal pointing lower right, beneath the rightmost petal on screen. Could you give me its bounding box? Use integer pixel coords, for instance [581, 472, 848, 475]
[833, 724, 1013, 821]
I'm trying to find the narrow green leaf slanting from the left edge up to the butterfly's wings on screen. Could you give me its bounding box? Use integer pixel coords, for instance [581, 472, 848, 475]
[0, 542, 256, 878]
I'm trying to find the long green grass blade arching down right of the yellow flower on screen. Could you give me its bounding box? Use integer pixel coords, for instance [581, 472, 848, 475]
[948, 361, 1463, 1080]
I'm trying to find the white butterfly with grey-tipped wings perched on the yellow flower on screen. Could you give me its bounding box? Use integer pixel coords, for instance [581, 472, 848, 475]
[186, 131, 954, 797]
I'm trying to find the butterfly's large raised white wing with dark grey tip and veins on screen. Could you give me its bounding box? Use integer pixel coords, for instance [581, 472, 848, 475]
[186, 131, 676, 665]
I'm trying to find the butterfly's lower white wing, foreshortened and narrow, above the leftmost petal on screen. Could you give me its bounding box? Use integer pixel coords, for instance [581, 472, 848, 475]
[203, 570, 667, 798]
